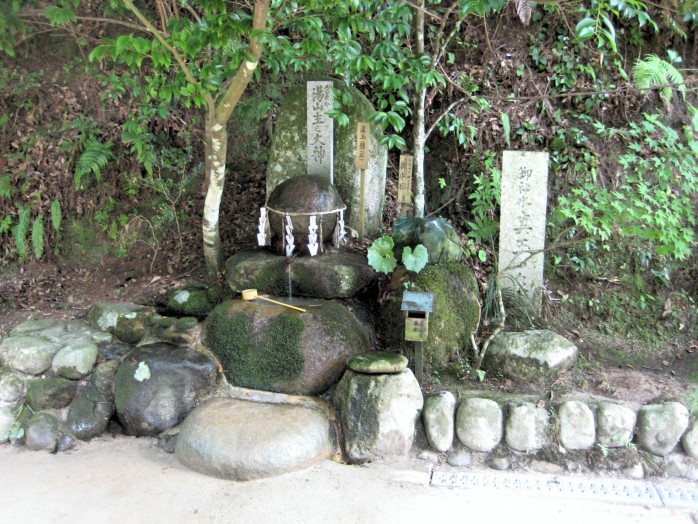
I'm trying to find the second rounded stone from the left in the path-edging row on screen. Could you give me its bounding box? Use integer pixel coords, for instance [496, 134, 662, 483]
[456, 398, 504, 453]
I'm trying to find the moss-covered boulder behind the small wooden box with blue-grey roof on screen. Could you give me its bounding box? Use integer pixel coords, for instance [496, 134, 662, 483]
[379, 263, 480, 368]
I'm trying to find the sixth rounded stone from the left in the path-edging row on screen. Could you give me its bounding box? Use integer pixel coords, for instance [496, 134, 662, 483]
[637, 402, 689, 456]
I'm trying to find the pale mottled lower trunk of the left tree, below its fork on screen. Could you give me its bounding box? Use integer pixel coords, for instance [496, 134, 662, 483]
[202, 114, 228, 275]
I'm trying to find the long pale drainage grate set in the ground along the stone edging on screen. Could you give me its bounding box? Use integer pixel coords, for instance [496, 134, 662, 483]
[431, 471, 698, 509]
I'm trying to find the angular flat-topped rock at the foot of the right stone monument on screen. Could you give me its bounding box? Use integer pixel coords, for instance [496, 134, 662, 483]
[483, 330, 577, 382]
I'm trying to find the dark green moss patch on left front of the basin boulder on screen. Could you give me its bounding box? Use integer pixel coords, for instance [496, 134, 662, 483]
[206, 303, 305, 389]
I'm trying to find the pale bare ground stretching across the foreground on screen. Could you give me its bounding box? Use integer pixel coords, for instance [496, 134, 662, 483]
[0, 437, 698, 524]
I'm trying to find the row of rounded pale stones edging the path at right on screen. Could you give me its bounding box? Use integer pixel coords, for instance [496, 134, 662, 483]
[422, 392, 698, 478]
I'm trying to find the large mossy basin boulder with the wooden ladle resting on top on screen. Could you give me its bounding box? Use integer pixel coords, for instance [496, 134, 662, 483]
[204, 300, 370, 395]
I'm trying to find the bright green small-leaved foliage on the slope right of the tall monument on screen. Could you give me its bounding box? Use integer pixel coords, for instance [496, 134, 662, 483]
[553, 114, 698, 262]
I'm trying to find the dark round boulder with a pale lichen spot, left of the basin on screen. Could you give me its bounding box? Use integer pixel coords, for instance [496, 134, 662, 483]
[115, 343, 216, 436]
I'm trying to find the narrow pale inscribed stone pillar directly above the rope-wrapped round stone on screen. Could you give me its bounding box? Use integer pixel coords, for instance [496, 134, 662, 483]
[307, 82, 334, 183]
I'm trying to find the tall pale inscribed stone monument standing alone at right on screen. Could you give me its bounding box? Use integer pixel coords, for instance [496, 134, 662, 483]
[499, 151, 548, 313]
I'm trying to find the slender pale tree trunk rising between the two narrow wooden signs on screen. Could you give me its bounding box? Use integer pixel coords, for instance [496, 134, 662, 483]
[412, 0, 427, 217]
